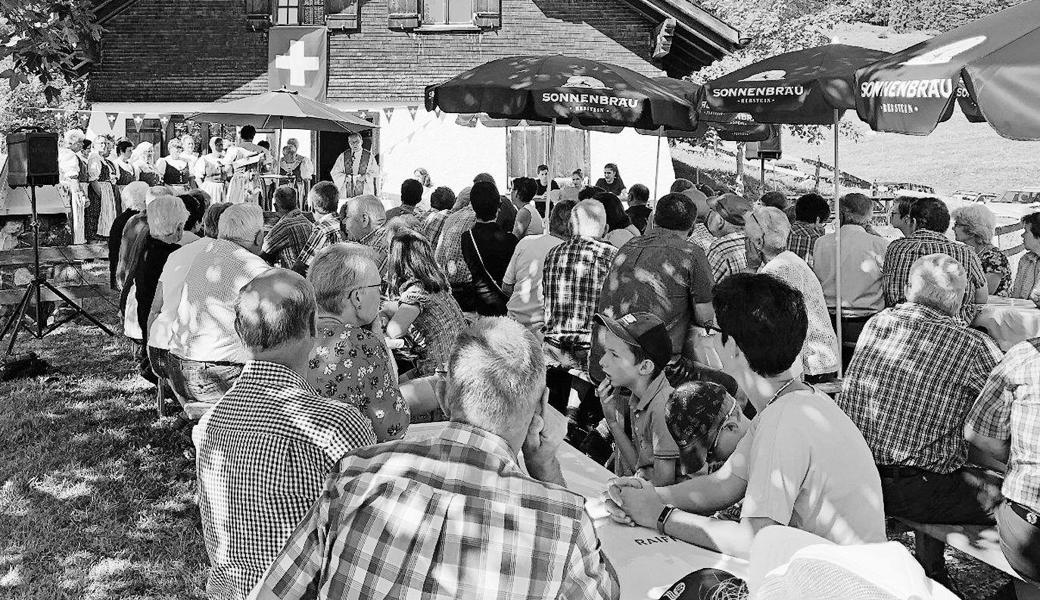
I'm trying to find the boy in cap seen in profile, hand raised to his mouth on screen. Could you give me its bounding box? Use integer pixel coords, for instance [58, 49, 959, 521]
[595, 312, 679, 486]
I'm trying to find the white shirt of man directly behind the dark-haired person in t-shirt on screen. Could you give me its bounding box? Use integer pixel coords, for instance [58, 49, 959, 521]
[758, 250, 838, 375]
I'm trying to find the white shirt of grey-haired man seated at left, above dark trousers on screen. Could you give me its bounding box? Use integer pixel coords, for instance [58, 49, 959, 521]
[170, 239, 270, 364]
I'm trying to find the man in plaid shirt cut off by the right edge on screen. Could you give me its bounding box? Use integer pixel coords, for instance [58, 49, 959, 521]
[964, 338, 1040, 581]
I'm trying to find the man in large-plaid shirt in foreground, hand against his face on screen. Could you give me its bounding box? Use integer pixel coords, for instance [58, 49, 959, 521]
[253, 317, 620, 600]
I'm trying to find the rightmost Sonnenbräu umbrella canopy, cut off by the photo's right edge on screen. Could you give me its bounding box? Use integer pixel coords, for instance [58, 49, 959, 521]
[856, 0, 1040, 140]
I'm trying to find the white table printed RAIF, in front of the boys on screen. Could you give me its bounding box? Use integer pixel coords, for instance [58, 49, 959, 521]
[408, 423, 748, 600]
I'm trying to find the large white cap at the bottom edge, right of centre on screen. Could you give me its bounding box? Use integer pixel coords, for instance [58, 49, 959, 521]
[748, 526, 957, 600]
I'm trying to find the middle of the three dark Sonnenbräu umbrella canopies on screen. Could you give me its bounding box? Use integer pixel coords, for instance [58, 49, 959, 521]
[700, 44, 889, 125]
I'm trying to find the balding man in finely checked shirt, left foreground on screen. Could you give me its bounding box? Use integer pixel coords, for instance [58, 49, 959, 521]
[192, 269, 375, 600]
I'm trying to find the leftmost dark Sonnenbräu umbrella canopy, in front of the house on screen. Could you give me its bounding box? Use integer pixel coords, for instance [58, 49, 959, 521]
[425, 55, 692, 130]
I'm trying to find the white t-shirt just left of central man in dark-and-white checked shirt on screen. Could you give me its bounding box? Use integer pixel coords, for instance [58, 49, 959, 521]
[502, 235, 564, 331]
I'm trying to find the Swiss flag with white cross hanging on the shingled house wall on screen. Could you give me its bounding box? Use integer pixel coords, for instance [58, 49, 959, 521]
[267, 27, 329, 101]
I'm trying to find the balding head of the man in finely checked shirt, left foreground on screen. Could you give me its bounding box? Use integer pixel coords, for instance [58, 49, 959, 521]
[235, 268, 316, 356]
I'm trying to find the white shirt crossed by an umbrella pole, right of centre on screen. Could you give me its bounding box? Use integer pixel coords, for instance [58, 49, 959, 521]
[812, 225, 889, 313]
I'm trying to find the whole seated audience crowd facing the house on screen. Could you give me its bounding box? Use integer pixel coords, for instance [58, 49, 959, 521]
[95, 134, 1040, 598]
